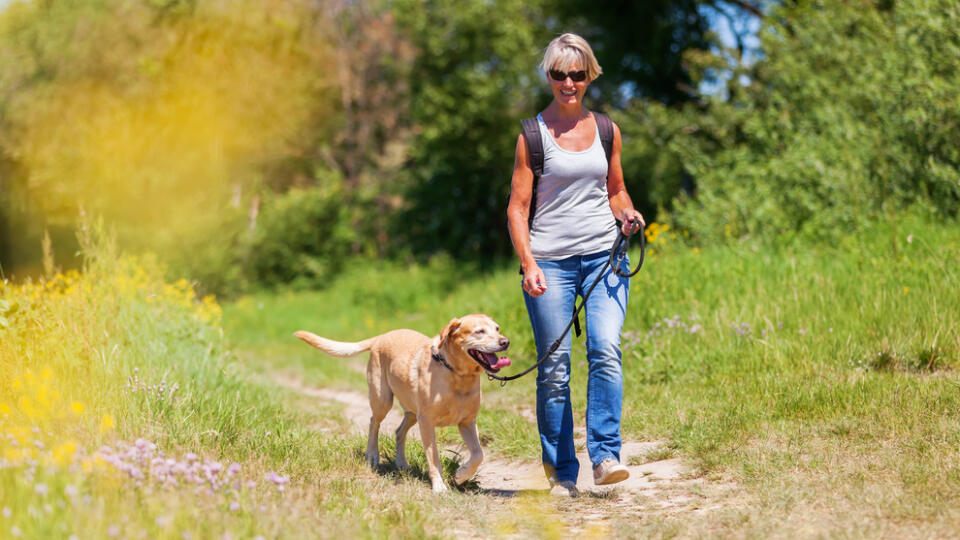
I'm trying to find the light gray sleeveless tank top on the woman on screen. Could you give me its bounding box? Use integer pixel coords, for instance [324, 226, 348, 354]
[530, 114, 617, 260]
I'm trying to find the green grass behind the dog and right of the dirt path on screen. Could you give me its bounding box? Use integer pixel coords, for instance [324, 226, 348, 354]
[225, 213, 960, 536]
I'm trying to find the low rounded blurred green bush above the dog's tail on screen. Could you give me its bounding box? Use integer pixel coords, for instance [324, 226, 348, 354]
[162, 180, 375, 296]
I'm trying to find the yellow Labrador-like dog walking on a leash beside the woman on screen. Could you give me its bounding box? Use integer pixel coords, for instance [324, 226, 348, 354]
[294, 314, 510, 493]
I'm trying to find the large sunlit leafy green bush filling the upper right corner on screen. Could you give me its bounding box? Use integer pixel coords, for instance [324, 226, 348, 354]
[648, 0, 960, 239]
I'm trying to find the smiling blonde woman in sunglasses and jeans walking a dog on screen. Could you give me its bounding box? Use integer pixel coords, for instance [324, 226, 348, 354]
[507, 34, 643, 497]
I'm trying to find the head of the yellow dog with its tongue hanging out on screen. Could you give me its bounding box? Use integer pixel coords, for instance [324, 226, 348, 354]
[437, 314, 510, 373]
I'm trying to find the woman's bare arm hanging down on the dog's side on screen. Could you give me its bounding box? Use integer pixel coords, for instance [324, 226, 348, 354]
[507, 134, 547, 296]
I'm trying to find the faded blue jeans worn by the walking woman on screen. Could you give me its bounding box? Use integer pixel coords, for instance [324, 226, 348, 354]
[523, 251, 630, 482]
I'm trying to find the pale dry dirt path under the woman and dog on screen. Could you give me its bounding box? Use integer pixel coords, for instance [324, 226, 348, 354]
[274, 375, 736, 519]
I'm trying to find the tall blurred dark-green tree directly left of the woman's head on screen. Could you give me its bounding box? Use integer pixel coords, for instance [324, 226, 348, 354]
[394, 0, 546, 260]
